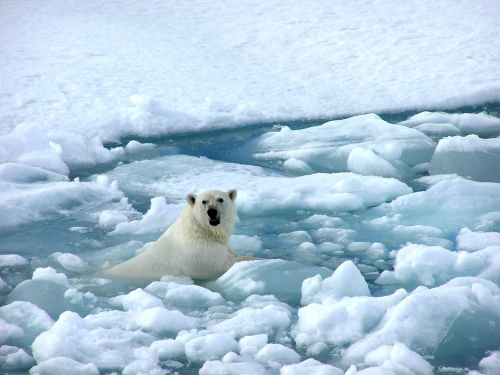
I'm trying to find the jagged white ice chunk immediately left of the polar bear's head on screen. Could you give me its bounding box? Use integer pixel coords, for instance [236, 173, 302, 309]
[110, 197, 185, 235]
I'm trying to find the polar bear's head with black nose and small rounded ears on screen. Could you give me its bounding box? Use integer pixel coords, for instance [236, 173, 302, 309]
[186, 189, 237, 233]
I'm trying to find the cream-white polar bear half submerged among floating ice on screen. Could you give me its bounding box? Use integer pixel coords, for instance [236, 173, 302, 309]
[105, 189, 258, 281]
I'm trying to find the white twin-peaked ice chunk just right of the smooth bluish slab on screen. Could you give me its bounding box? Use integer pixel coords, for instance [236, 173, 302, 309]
[300, 260, 371, 305]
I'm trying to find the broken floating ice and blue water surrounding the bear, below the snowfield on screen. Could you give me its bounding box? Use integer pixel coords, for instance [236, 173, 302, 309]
[0, 112, 500, 375]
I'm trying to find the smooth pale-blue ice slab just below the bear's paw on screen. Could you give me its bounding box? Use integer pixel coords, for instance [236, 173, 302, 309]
[206, 259, 331, 302]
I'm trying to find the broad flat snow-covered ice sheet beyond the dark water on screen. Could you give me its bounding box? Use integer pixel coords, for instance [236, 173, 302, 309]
[0, 1, 498, 141]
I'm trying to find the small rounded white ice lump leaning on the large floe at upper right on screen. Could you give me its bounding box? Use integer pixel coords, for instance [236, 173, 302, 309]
[347, 147, 399, 178]
